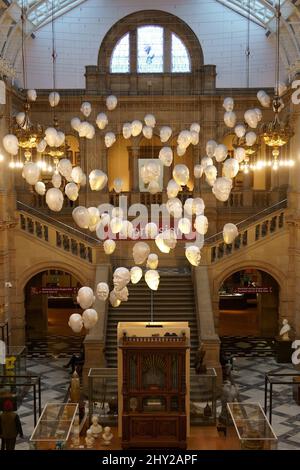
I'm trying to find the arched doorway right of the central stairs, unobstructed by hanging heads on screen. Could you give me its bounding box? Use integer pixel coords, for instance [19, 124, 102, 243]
[219, 268, 279, 337]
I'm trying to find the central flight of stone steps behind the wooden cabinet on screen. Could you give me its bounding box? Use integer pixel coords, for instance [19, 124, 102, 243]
[105, 272, 198, 367]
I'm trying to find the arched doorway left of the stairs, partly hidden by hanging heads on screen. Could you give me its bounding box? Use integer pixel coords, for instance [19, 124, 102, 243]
[24, 269, 84, 340]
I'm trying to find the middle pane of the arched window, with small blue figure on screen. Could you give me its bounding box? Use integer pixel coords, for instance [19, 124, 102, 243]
[137, 26, 164, 73]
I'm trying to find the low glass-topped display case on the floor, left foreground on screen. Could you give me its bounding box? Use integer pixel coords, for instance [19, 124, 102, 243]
[29, 403, 78, 450]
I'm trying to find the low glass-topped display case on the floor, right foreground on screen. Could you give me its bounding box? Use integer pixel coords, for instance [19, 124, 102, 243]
[227, 403, 277, 450]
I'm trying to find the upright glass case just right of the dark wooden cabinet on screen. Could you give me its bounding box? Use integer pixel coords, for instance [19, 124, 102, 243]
[190, 367, 217, 426]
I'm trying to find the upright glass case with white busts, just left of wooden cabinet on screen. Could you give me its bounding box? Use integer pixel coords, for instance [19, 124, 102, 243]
[88, 367, 118, 426]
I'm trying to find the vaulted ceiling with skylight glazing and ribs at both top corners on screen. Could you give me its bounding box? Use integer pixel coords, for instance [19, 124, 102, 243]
[0, 0, 300, 79]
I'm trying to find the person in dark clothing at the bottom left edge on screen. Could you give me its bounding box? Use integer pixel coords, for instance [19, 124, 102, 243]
[0, 399, 24, 450]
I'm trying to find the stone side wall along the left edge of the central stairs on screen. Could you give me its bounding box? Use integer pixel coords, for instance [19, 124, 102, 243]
[83, 264, 110, 392]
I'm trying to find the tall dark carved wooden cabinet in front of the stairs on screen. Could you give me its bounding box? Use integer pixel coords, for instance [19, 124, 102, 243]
[119, 332, 189, 449]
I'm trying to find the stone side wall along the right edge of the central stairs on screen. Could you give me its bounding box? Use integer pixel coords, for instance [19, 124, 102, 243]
[193, 266, 222, 384]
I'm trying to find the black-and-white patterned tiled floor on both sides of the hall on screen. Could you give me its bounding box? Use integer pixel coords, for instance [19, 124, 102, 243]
[9, 357, 300, 450]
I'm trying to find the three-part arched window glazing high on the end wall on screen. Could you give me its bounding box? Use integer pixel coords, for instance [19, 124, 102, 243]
[110, 25, 191, 73]
